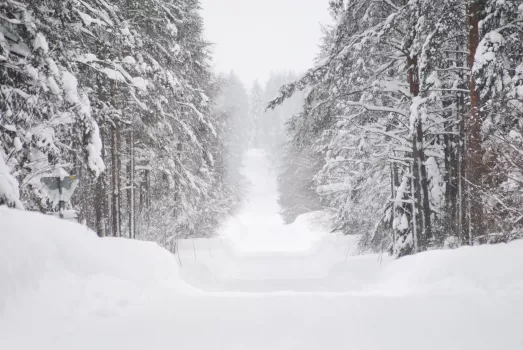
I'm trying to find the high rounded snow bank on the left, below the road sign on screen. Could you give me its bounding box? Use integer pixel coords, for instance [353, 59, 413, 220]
[0, 207, 189, 313]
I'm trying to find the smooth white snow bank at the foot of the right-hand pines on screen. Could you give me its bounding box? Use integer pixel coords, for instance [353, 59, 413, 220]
[368, 241, 523, 295]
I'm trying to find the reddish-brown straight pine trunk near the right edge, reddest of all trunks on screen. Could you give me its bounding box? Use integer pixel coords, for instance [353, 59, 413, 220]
[466, 0, 484, 244]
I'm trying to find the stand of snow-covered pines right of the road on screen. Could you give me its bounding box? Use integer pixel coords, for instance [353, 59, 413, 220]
[270, 0, 523, 256]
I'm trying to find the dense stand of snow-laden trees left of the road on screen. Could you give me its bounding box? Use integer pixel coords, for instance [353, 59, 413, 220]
[0, 0, 241, 246]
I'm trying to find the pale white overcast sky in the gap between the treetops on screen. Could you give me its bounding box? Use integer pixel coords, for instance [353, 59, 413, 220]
[201, 0, 330, 87]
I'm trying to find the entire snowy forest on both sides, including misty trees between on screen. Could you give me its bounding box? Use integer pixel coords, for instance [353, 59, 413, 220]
[0, 0, 523, 257]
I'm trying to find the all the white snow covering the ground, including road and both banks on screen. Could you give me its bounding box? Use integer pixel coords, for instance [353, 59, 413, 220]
[0, 151, 523, 350]
